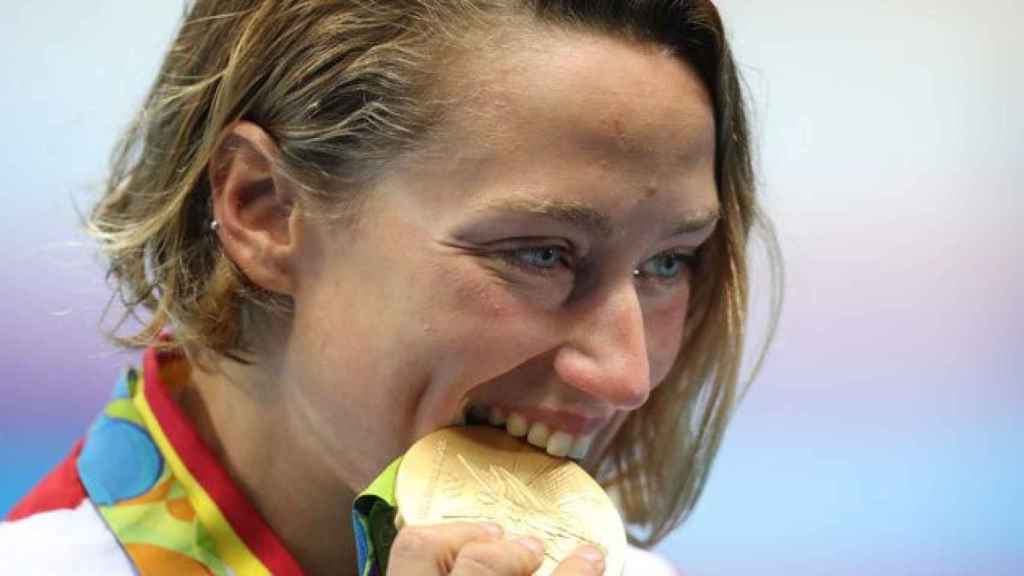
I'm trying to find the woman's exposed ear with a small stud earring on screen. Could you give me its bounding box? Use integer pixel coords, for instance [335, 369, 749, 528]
[208, 121, 298, 295]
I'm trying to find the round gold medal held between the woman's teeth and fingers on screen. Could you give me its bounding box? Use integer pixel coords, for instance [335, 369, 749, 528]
[394, 426, 626, 576]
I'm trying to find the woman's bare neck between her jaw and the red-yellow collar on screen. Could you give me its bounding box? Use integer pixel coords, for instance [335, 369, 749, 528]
[178, 360, 356, 575]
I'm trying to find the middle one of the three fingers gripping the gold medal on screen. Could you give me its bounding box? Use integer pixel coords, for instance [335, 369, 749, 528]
[451, 538, 544, 576]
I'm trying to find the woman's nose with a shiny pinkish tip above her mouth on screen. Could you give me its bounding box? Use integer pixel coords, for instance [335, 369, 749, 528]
[554, 279, 650, 410]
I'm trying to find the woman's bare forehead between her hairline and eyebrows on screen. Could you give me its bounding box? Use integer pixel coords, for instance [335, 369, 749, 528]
[393, 29, 717, 226]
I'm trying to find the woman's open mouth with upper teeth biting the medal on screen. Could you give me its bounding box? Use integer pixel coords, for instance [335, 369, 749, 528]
[455, 405, 598, 460]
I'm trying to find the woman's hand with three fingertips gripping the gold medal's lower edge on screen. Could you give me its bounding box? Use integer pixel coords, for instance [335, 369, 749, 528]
[387, 523, 604, 576]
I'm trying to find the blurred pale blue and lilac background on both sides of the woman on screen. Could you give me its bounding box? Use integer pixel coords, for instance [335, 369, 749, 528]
[0, 0, 1024, 576]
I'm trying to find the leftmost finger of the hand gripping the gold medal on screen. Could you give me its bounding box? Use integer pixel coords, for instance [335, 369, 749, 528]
[387, 523, 502, 576]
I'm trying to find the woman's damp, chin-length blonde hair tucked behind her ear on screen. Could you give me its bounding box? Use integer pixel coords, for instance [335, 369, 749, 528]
[89, 0, 781, 546]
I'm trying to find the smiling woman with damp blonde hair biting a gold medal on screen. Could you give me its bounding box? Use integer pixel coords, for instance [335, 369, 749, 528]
[3, 0, 782, 576]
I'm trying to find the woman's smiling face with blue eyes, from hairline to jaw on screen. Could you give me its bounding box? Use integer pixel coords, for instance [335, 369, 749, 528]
[282, 28, 719, 490]
